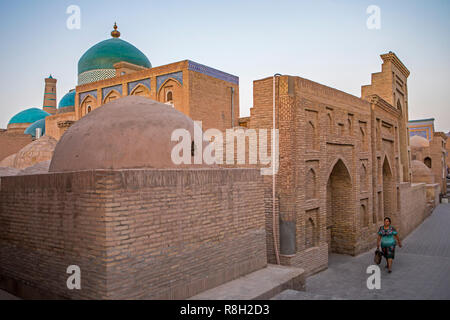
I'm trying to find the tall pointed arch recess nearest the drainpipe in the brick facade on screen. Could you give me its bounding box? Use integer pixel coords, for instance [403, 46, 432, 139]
[327, 160, 355, 254]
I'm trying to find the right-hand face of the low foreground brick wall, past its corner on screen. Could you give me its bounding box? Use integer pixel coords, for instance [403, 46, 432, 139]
[100, 169, 267, 299]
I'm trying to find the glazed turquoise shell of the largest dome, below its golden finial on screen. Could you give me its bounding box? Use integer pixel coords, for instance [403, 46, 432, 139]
[78, 38, 152, 75]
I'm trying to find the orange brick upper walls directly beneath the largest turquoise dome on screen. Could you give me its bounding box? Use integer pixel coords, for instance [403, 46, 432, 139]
[75, 60, 239, 134]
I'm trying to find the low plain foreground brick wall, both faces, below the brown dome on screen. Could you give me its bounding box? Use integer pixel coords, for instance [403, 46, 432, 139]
[0, 169, 267, 299]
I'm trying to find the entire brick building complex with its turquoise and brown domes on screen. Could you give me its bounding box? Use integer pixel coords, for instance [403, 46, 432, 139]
[0, 27, 446, 299]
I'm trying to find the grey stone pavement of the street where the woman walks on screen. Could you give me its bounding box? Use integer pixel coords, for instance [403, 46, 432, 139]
[273, 204, 450, 300]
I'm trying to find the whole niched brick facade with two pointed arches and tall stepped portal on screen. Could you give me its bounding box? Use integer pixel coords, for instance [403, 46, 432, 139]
[245, 53, 433, 274]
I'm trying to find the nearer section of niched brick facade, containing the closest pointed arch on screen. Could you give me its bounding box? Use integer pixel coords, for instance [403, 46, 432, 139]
[248, 76, 372, 274]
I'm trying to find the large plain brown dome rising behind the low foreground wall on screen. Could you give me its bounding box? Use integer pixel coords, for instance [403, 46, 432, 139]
[49, 96, 211, 172]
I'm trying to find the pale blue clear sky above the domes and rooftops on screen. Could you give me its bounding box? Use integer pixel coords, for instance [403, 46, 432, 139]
[0, 0, 450, 132]
